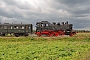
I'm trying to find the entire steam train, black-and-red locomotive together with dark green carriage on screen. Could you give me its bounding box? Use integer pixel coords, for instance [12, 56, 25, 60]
[0, 21, 76, 37]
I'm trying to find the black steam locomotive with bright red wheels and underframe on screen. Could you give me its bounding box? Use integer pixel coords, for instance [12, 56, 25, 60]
[35, 21, 76, 36]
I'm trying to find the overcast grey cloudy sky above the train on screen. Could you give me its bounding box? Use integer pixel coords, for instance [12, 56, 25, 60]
[0, 0, 90, 30]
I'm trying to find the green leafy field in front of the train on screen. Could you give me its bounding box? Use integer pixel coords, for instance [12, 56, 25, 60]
[0, 33, 90, 60]
